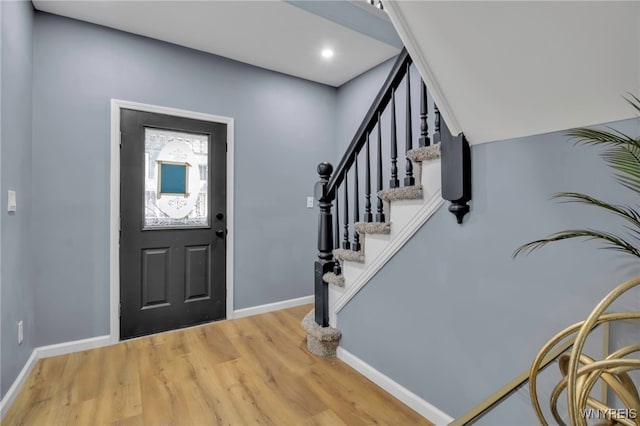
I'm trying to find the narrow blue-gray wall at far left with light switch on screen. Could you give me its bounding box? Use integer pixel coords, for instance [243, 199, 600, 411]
[0, 1, 34, 397]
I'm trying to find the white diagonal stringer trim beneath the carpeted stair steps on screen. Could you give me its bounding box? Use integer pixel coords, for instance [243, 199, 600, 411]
[330, 188, 444, 314]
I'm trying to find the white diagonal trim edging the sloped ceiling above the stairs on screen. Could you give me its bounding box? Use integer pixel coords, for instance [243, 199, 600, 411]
[384, 1, 462, 136]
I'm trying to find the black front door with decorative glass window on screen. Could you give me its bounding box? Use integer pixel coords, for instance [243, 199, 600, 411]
[120, 109, 227, 339]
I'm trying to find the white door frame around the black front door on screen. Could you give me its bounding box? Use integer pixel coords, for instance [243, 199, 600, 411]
[109, 99, 234, 344]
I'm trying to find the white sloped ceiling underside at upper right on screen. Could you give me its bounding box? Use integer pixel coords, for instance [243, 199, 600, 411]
[385, 1, 640, 143]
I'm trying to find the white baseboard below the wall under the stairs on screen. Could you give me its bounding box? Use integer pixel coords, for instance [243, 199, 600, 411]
[336, 347, 455, 426]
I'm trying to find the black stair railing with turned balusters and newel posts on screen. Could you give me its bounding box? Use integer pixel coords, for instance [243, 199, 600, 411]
[315, 49, 470, 327]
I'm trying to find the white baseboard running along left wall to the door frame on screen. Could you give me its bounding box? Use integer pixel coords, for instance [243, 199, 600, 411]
[0, 336, 111, 419]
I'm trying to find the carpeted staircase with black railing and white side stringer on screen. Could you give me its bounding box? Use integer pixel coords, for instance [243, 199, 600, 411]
[302, 50, 471, 357]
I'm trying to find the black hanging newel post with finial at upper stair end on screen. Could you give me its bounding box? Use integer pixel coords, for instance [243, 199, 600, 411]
[440, 120, 471, 223]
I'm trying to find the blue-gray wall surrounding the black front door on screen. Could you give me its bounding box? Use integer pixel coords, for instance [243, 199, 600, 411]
[33, 13, 336, 345]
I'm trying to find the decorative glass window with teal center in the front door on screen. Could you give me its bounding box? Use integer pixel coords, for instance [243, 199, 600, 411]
[143, 127, 209, 230]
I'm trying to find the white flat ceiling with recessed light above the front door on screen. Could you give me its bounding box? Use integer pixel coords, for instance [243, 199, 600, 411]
[33, 0, 400, 86]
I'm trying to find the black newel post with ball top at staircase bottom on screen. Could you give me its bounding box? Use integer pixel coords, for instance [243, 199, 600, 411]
[314, 163, 335, 327]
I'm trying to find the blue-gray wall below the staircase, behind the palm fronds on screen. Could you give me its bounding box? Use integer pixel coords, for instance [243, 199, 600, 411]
[338, 120, 640, 417]
